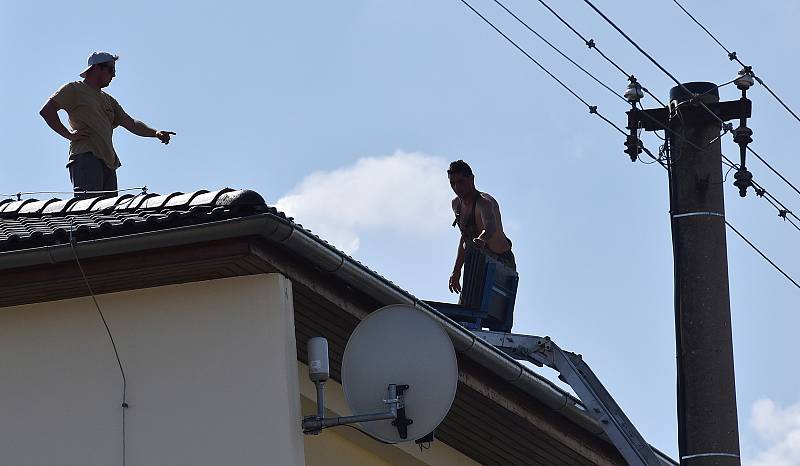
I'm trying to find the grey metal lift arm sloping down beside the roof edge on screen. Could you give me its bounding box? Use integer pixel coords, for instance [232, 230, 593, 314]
[473, 330, 663, 466]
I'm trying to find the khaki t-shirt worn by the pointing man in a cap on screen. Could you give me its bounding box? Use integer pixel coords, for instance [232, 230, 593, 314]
[50, 81, 128, 169]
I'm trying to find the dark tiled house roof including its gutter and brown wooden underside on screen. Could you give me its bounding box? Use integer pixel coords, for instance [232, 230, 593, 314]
[0, 188, 674, 464]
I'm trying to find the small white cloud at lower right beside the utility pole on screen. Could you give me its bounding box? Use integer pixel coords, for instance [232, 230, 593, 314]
[745, 399, 800, 466]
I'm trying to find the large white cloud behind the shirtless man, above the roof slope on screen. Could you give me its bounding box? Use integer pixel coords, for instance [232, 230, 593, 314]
[276, 151, 452, 253]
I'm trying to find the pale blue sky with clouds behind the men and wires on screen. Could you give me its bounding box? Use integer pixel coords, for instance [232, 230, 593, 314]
[0, 0, 800, 465]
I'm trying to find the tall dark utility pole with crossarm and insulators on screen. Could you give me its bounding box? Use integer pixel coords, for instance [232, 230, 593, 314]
[626, 81, 751, 466]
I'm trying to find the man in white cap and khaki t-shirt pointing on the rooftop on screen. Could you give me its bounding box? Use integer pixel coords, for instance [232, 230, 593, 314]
[39, 52, 175, 198]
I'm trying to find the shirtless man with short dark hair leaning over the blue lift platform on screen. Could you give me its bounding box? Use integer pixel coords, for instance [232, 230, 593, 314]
[447, 160, 517, 293]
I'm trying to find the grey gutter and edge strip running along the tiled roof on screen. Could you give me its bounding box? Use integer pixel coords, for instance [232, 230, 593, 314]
[0, 213, 677, 464]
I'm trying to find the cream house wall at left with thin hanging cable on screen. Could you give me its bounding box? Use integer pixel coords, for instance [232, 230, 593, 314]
[0, 274, 304, 466]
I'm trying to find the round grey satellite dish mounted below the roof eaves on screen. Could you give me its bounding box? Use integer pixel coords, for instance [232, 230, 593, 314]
[342, 304, 458, 443]
